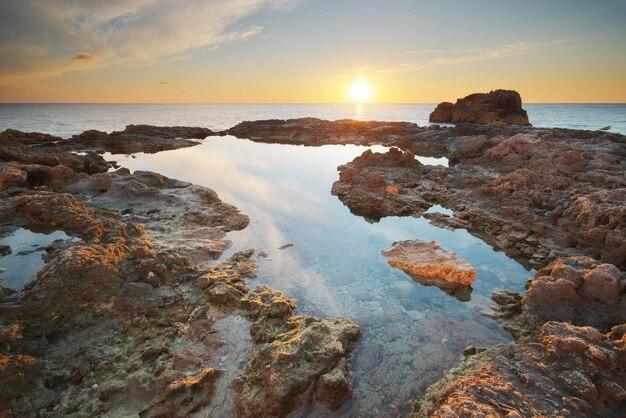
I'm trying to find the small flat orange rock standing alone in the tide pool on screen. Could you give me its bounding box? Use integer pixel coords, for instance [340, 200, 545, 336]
[382, 240, 476, 296]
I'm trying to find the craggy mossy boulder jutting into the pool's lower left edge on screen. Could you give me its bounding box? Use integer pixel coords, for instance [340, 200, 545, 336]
[234, 286, 360, 417]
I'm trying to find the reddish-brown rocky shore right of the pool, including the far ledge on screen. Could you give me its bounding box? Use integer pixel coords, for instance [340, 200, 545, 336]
[229, 94, 626, 417]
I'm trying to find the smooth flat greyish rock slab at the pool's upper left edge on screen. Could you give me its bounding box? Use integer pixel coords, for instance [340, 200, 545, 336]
[64, 168, 249, 259]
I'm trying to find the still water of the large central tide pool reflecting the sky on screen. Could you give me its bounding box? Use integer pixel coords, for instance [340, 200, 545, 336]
[106, 137, 529, 416]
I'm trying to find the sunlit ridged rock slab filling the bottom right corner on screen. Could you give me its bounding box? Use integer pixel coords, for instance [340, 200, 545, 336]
[414, 322, 626, 417]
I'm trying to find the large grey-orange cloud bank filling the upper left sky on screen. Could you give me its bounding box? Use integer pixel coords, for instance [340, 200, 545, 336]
[0, 0, 299, 85]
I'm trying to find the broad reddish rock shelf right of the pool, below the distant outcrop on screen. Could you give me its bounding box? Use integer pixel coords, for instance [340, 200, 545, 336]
[332, 127, 626, 268]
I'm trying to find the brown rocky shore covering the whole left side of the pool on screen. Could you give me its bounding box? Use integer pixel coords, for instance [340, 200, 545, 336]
[0, 127, 360, 417]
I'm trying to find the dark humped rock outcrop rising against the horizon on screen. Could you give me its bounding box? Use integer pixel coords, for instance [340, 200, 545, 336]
[428, 90, 529, 125]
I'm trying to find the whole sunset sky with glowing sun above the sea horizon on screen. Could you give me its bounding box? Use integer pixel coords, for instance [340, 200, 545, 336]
[0, 0, 626, 103]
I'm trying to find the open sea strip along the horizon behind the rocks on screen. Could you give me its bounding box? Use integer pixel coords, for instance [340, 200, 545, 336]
[0, 104, 626, 137]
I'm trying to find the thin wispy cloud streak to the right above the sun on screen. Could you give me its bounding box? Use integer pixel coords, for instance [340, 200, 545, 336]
[376, 40, 567, 73]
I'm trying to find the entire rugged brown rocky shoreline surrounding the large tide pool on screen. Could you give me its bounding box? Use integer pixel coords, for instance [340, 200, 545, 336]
[0, 92, 626, 416]
